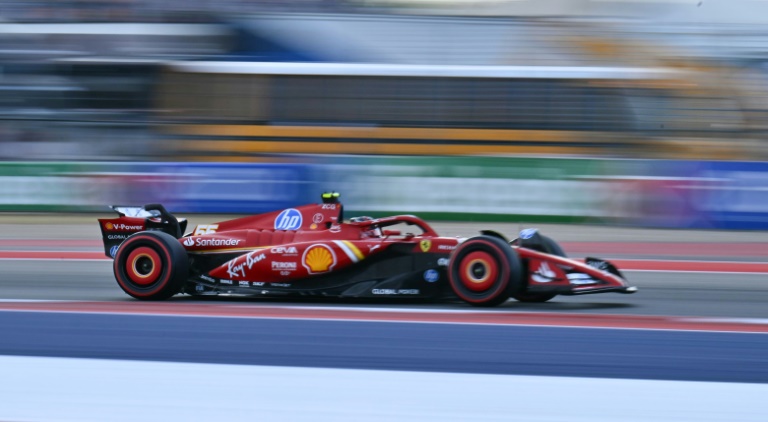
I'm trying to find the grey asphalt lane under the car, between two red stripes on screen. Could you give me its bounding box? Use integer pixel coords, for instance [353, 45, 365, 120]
[0, 260, 768, 318]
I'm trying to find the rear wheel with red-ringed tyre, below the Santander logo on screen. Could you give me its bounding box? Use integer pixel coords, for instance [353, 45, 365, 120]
[113, 231, 189, 300]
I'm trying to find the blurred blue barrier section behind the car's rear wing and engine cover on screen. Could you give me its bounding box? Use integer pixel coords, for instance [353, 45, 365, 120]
[63, 162, 319, 214]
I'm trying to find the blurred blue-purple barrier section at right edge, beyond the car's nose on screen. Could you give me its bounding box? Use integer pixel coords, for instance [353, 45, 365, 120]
[605, 160, 768, 230]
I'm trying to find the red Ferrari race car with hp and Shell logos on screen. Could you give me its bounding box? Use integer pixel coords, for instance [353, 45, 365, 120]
[99, 193, 637, 306]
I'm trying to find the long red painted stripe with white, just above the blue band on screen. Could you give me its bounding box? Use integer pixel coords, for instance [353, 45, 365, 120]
[0, 301, 768, 333]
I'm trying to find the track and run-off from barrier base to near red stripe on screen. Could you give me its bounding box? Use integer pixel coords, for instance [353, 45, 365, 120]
[0, 214, 768, 318]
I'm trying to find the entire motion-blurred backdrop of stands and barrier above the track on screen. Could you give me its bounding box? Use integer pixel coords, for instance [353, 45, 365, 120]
[0, 0, 768, 229]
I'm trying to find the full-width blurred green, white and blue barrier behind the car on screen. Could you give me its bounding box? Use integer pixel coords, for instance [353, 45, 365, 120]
[0, 157, 768, 230]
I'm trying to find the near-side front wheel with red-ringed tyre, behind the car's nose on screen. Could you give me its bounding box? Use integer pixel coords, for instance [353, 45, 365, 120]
[448, 236, 522, 306]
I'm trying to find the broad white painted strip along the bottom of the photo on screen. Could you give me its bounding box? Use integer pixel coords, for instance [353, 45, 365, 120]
[0, 356, 768, 422]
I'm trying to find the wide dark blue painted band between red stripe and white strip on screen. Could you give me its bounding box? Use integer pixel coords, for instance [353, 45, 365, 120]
[0, 312, 768, 383]
